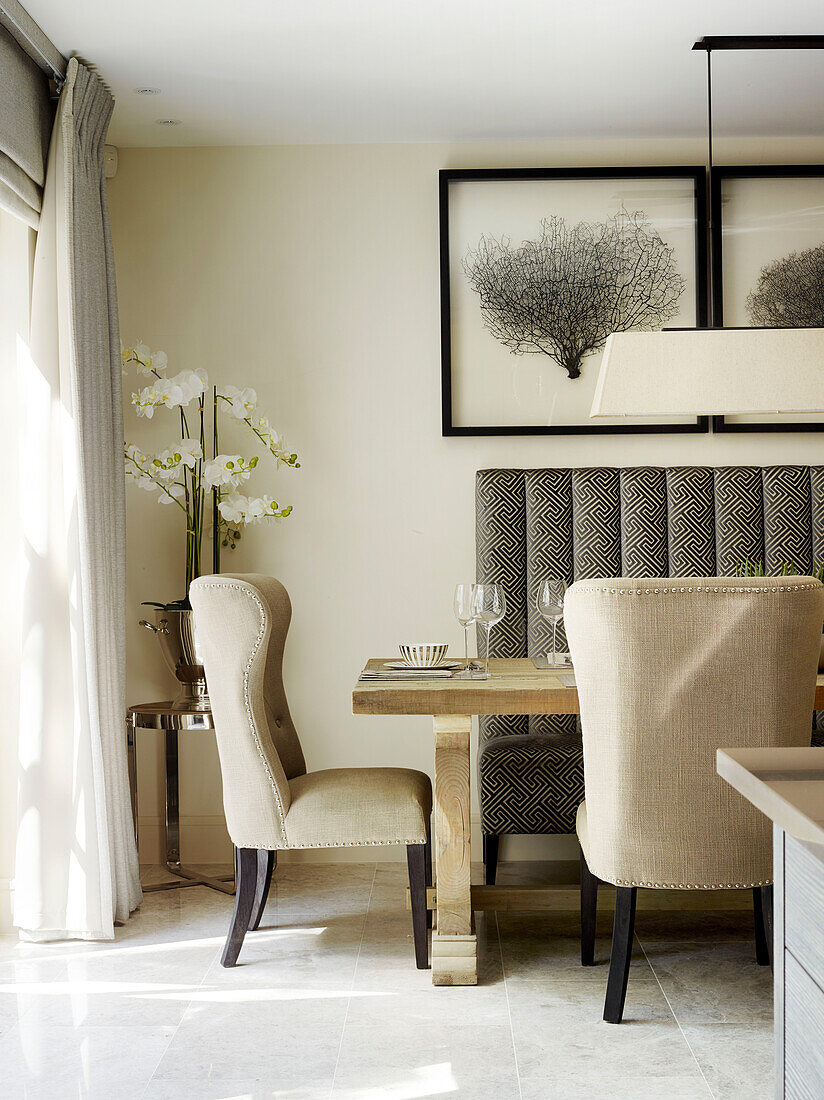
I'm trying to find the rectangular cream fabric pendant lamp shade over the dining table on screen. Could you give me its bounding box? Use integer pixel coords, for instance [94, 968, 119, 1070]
[590, 329, 824, 417]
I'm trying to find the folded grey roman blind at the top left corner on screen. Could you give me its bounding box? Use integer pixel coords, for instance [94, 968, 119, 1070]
[0, 26, 53, 228]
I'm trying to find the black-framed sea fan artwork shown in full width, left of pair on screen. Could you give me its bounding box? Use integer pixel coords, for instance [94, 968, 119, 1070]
[440, 167, 708, 436]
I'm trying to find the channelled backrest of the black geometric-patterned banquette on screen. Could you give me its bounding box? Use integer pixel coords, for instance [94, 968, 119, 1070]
[475, 465, 824, 739]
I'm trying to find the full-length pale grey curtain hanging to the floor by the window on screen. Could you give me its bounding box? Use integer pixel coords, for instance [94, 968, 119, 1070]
[14, 58, 141, 939]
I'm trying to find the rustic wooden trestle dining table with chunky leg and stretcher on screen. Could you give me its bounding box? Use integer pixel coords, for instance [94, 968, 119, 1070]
[352, 658, 824, 986]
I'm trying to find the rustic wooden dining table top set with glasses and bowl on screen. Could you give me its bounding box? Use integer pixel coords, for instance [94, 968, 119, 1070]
[352, 657, 824, 715]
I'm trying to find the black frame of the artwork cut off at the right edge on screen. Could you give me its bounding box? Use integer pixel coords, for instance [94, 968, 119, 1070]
[710, 164, 824, 433]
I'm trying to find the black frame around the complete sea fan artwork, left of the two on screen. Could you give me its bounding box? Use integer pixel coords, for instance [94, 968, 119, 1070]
[439, 165, 710, 436]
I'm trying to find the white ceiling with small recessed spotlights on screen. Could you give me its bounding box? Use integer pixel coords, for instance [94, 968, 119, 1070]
[24, 0, 824, 146]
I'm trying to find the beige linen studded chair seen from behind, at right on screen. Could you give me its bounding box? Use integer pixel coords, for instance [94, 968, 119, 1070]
[564, 576, 824, 1023]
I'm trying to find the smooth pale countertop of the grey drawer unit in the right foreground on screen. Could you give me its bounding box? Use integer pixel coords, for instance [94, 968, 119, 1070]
[717, 743, 824, 844]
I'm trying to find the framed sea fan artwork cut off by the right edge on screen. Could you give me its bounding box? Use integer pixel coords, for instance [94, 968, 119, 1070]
[712, 164, 824, 431]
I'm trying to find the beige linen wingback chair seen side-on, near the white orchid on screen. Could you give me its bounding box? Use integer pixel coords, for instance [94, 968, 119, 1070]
[189, 574, 432, 969]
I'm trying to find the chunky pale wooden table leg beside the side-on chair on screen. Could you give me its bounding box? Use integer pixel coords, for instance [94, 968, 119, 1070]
[432, 715, 477, 986]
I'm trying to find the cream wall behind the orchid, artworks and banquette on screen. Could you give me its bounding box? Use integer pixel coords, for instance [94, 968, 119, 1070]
[109, 141, 824, 860]
